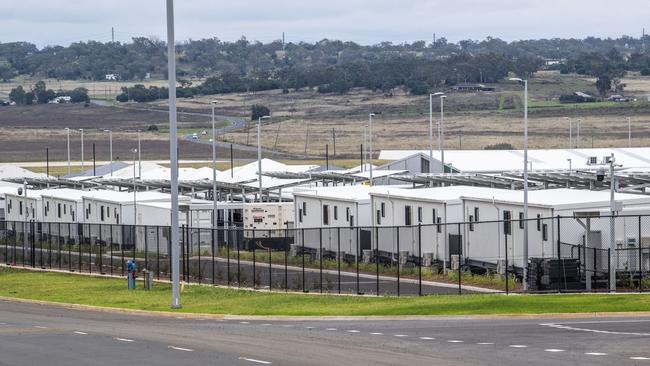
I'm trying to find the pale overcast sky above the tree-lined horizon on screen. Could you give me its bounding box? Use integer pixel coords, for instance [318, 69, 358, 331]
[0, 0, 650, 46]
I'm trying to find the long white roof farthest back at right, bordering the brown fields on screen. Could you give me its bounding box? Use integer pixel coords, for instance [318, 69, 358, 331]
[379, 147, 650, 173]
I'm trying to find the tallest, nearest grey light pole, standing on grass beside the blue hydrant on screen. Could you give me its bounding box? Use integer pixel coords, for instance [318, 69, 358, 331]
[167, 0, 181, 309]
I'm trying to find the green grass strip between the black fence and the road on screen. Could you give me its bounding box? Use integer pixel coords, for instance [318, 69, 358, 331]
[0, 268, 650, 316]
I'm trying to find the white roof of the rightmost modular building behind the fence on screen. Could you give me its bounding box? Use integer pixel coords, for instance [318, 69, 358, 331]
[463, 188, 650, 209]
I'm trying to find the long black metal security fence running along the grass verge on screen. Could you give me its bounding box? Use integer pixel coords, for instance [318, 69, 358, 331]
[0, 213, 650, 296]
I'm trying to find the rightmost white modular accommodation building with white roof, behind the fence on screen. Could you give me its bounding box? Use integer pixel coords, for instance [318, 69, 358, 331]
[461, 189, 650, 268]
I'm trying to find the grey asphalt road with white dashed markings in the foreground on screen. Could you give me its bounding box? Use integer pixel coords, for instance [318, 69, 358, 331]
[0, 301, 650, 366]
